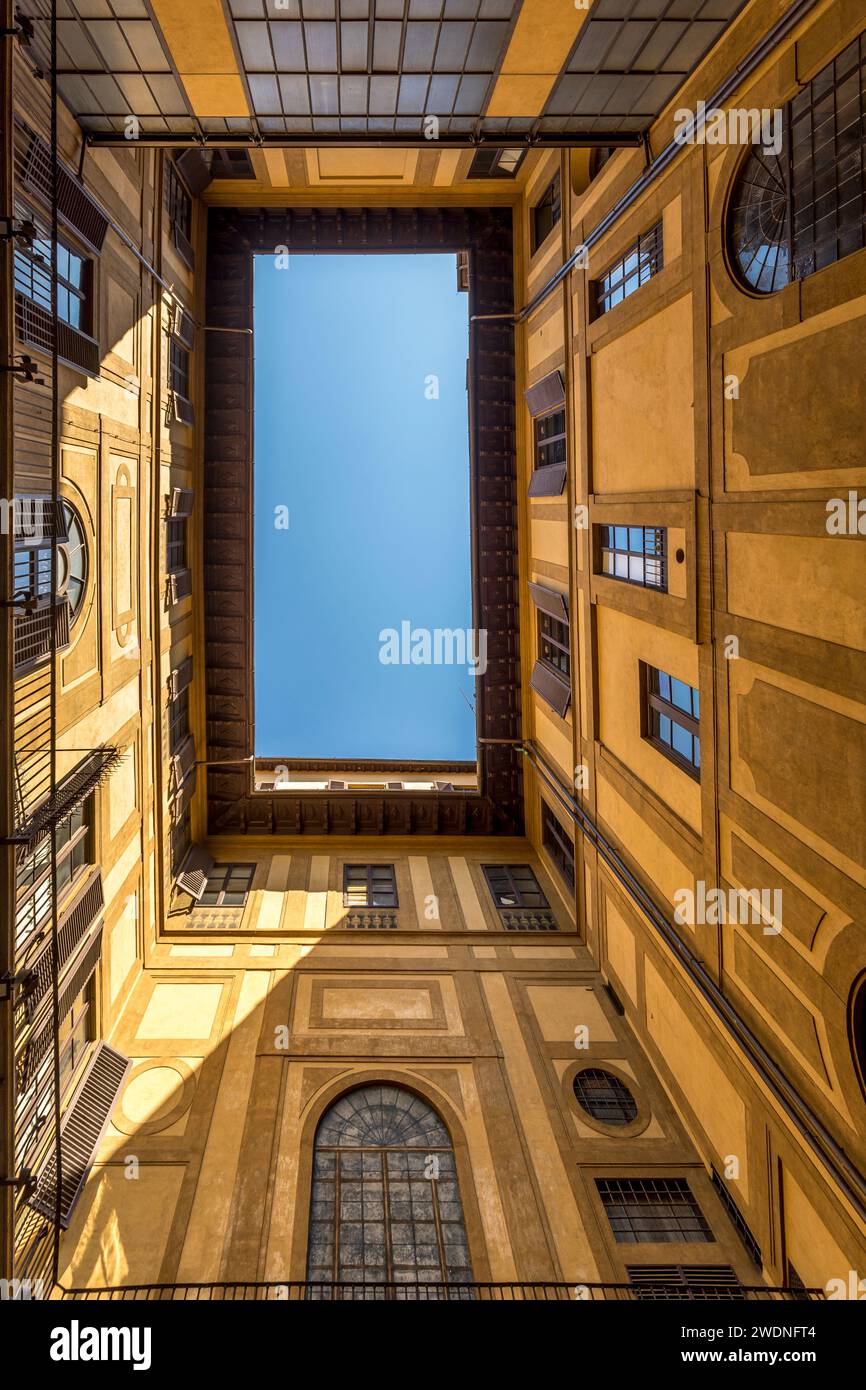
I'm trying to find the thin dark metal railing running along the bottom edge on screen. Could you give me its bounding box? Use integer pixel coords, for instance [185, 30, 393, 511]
[54, 1280, 824, 1302]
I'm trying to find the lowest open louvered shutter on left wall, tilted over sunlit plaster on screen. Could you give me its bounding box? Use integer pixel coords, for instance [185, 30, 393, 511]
[31, 1043, 132, 1230]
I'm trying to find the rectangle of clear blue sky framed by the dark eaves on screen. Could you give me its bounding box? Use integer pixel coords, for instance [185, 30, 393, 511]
[254, 254, 475, 759]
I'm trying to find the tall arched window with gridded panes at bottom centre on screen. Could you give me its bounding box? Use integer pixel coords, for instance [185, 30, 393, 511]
[307, 1086, 473, 1298]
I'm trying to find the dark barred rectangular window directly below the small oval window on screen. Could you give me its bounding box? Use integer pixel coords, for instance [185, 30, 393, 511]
[595, 1177, 713, 1245]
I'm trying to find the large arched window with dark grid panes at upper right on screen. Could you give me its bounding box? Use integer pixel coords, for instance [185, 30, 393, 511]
[727, 35, 866, 295]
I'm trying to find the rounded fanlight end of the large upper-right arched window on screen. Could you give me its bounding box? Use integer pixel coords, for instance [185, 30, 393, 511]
[727, 145, 791, 295]
